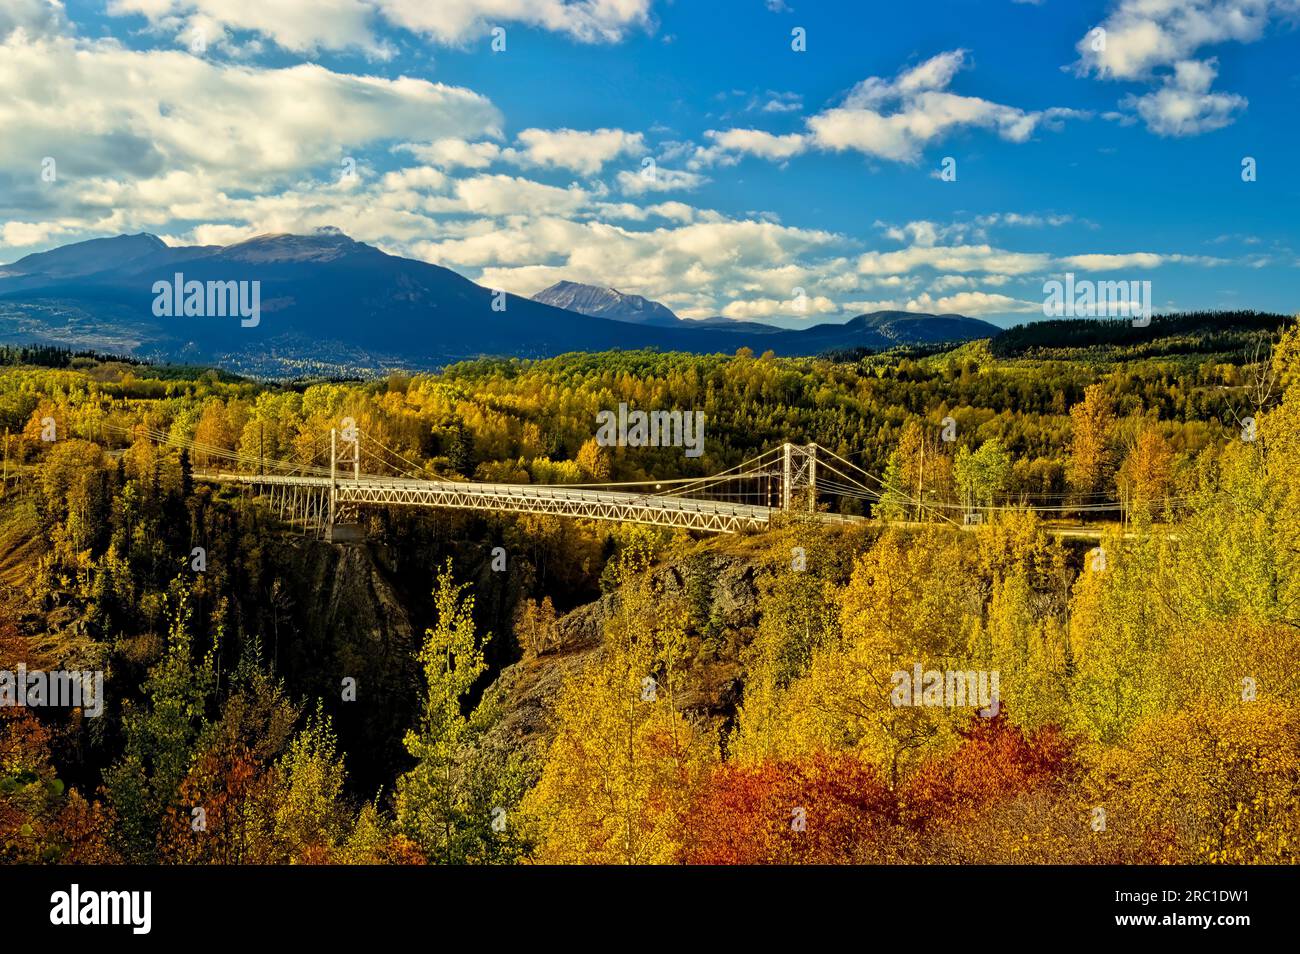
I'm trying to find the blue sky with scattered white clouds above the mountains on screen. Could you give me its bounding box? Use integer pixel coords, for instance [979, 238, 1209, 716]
[0, 0, 1300, 326]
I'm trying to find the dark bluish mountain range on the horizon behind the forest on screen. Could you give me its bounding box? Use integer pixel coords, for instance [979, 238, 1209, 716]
[0, 229, 998, 376]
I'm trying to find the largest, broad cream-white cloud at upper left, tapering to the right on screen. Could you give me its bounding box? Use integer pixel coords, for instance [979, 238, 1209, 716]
[0, 34, 501, 187]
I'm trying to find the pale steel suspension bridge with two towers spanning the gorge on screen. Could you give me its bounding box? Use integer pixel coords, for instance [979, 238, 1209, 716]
[109, 421, 1118, 542]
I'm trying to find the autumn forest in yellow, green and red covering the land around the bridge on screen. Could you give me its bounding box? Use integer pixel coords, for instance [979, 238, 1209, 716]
[0, 315, 1300, 864]
